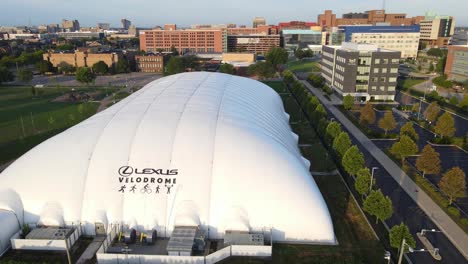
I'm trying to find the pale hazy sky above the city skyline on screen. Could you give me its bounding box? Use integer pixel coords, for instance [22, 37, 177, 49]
[0, 0, 468, 27]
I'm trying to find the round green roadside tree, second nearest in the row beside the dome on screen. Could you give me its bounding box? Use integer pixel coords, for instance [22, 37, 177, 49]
[363, 190, 393, 223]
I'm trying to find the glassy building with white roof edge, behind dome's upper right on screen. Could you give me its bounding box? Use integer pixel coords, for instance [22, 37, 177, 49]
[281, 29, 322, 54]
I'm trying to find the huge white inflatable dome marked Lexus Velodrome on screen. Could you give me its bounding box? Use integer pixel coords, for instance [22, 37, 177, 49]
[0, 72, 336, 252]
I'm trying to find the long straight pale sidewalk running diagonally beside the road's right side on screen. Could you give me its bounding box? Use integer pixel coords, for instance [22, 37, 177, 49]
[302, 81, 468, 259]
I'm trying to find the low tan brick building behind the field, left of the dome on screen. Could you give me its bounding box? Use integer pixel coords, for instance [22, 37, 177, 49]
[43, 50, 122, 68]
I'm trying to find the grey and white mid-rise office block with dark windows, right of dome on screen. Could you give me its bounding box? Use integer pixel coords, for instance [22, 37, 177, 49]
[321, 42, 400, 102]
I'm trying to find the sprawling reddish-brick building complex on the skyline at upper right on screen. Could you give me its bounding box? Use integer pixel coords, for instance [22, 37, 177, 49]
[317, 10, 424, 28]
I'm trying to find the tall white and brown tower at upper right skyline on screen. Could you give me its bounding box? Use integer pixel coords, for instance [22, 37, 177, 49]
[420, 13, 455, 48]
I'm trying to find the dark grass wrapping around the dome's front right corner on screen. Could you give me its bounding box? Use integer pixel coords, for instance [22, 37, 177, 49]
[222, 175, 384, 264]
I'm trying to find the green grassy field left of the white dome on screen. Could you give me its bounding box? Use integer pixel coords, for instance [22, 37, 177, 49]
[0, 87, 122, 164]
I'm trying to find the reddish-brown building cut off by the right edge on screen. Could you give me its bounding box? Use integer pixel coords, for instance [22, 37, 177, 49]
[444, 45, 468, 82]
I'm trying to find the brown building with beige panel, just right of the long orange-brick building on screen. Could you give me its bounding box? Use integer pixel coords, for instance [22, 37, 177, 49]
[227, 34, 280, 54]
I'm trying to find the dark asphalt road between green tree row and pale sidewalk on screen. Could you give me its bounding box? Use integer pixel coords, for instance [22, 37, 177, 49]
[304, 80, 468, 264]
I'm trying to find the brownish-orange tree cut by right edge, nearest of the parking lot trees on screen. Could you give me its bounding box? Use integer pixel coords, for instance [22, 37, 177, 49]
[439, 167, 466, 205]
